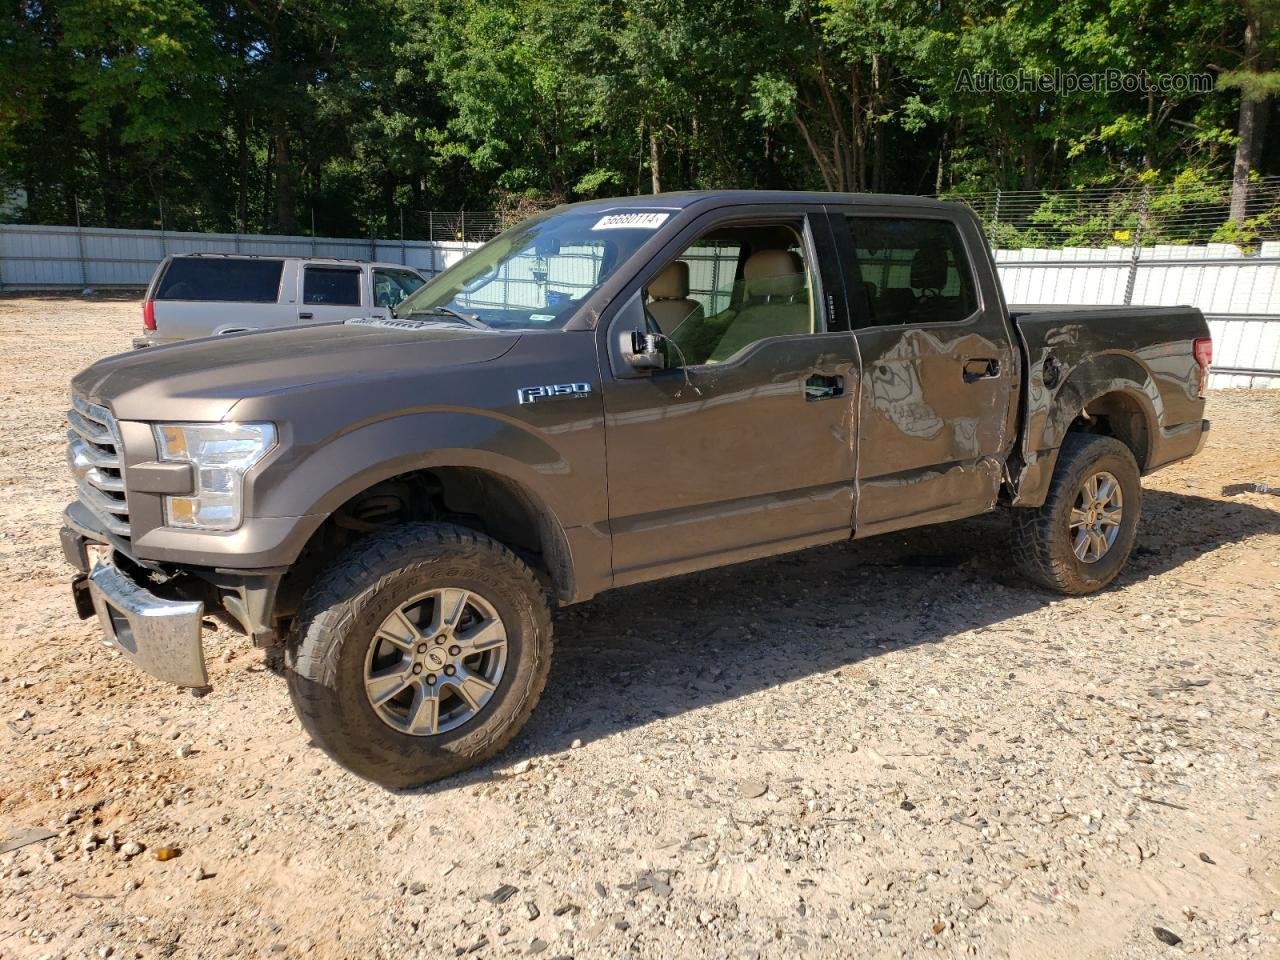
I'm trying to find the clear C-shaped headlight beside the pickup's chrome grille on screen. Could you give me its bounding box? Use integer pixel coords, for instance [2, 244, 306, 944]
[152, 424, 275, 530]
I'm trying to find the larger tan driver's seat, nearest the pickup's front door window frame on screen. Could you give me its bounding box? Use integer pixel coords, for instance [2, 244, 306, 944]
[708, 250, 813, 364]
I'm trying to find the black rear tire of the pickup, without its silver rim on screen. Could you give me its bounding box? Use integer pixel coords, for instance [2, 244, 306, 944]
[1012, 434, 1142, 595]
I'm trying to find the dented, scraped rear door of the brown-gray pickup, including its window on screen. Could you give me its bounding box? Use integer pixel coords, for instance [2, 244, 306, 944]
[832, 205, 1021, 536]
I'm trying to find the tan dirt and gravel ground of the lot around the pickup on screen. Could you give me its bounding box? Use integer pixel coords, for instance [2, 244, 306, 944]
[0, 300, 1280, 960]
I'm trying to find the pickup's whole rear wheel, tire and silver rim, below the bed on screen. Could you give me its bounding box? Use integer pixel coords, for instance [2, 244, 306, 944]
[1012, 434, 1142, 594]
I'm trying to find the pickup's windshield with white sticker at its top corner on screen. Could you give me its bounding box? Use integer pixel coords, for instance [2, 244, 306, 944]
[396, 207, 672, 330]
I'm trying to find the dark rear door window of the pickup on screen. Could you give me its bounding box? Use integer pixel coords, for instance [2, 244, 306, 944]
[847, 216, 978, 326]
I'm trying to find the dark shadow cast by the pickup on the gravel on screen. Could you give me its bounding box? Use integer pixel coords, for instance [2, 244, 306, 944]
[468, 490, 1280, 788]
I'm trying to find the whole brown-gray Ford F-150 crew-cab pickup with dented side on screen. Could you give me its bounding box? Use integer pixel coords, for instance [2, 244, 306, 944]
[63, 192, 1210, 786]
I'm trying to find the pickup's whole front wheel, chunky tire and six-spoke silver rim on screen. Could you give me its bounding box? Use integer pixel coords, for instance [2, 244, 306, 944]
[285, 524, 552, 787]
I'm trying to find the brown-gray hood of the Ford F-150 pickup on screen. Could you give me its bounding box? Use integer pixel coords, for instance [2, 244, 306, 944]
[72, 324, 520, 421]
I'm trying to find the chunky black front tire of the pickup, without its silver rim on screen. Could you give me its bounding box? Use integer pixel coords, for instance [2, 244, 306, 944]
[285, 524, 552, 788]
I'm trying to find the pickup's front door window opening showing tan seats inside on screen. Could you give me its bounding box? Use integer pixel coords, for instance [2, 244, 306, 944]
[645, 224, 814, 366]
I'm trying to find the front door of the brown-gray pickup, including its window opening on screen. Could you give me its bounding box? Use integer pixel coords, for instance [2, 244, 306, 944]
[602, 207, 858, 585]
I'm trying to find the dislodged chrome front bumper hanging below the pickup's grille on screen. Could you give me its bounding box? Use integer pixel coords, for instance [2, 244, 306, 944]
[87, 557, 209, 687]
